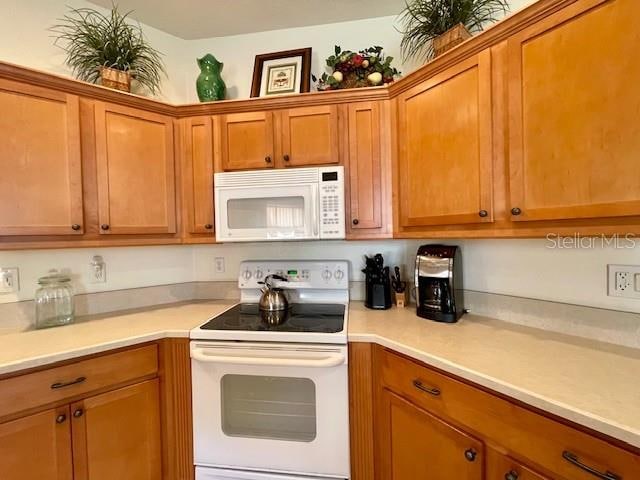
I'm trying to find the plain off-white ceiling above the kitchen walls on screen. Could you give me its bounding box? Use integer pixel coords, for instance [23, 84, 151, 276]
[89, 0, 405, 40]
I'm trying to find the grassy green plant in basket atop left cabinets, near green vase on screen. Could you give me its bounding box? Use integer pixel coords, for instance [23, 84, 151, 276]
[51, 5, 165, 93]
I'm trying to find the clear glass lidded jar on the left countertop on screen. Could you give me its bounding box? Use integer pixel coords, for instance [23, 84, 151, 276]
[35, 270, 75, 328]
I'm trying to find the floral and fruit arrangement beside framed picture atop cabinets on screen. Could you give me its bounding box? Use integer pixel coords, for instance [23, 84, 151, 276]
[312, 45, 400, 90]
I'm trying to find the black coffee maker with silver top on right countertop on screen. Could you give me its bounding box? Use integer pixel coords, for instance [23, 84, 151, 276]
[415, 245, 464, 323]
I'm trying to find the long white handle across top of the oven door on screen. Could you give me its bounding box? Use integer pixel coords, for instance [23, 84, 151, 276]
[191, 348, 345, 368]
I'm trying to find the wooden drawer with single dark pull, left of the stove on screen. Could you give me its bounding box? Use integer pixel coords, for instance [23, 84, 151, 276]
[0, 345, 158, 417]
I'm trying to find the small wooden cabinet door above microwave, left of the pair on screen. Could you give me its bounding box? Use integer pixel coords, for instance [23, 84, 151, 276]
[220, 112, 274, 170]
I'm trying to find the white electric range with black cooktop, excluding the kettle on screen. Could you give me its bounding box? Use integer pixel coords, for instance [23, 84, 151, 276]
[191, 261, 350, 480]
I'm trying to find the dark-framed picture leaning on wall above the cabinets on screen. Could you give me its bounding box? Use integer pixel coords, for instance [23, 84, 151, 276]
[251, 48, 311, 97]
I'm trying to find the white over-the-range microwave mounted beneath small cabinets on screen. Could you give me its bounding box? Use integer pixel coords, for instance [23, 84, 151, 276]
[214, 167, 345, 242]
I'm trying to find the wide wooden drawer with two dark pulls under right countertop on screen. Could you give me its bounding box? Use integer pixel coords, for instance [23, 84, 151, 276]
[375, 348, 640, 480]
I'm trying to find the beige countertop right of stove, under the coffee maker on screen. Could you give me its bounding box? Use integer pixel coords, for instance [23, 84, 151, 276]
[349, 303, 640, 447]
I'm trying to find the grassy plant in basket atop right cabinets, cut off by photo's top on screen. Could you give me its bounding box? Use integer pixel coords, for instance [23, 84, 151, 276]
[400, 0, 509, 60]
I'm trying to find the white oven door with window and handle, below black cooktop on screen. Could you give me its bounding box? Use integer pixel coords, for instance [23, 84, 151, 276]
[191, 342, 349, 479]
